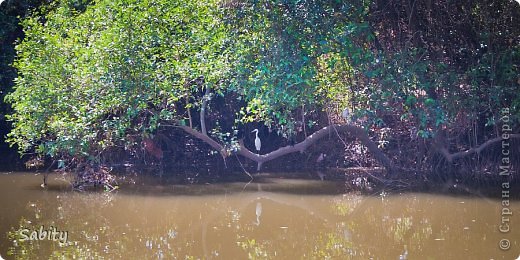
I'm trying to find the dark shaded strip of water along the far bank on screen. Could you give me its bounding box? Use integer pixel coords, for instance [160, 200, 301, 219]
[7, 172, 520, 201]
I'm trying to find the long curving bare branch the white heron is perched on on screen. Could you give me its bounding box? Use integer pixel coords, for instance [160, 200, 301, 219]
[179, 125, 394, 172]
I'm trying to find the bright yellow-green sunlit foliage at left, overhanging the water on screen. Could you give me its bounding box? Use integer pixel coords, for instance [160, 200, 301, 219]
[7, 1, 228, 159]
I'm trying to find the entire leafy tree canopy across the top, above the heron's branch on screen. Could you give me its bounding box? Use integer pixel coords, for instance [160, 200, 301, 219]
[7, 0, 520, 180]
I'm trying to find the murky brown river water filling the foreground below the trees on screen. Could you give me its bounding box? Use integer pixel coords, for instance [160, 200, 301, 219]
[0, 173, 520, 259]
